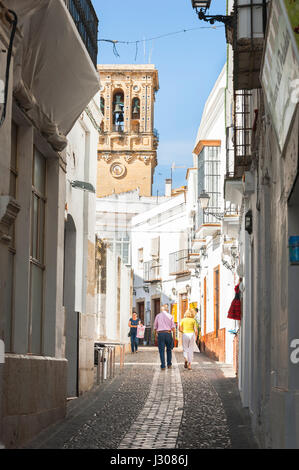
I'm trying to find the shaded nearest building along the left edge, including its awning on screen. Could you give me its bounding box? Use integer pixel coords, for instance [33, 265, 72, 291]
[0, 0, 99, 447]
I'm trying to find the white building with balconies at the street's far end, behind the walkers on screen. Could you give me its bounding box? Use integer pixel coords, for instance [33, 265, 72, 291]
[131, 190, 195, 343]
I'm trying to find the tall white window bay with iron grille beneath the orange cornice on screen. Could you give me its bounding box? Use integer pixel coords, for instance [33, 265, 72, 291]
[197, 146, 222, 227]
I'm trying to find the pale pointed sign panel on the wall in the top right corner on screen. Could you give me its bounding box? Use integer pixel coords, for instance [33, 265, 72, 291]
[261, 0, 299, 152]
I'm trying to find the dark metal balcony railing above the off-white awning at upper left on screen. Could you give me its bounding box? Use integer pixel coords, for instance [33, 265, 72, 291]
[64, 0, 99, 67]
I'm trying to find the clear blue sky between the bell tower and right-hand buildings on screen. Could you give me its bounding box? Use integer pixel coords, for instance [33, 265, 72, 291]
[93, 0, 226, 195]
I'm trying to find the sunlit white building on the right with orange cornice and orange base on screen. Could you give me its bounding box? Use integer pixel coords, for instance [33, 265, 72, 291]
[188, 65, 238, 364]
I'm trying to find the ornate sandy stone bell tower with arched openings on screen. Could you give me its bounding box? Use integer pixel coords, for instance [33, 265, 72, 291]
[97, 64, 159, 197]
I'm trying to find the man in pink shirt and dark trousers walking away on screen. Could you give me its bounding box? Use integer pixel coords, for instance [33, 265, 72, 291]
[154, 304, 175, 370]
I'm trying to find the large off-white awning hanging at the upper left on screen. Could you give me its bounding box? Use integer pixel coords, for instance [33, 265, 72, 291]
[4, 0, 100, 149]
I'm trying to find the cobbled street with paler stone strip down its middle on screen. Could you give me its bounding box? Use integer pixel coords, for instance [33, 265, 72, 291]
[25, 347, 257, 449]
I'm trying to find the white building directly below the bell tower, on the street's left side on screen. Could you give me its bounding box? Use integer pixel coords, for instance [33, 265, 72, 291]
[96, 188, 169, 344]
